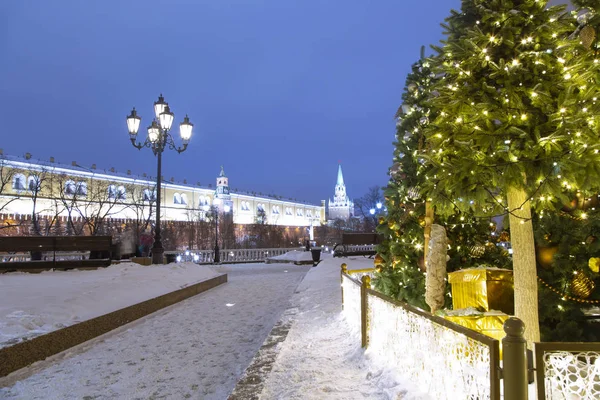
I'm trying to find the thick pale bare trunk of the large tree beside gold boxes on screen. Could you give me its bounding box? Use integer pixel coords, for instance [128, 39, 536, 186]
[507, 187, 540, 348]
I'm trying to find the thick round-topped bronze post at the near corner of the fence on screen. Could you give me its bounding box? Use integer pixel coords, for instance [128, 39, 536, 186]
[502, 317, 527, 400]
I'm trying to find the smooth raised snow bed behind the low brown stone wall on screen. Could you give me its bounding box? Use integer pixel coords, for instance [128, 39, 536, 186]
[0, 263, 218, 348]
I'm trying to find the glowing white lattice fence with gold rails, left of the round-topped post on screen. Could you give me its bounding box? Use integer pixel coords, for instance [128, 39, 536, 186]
[342, 269, 500, 400]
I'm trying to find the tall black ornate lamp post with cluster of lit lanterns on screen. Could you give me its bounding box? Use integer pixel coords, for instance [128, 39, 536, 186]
[127, 94, 194, 264]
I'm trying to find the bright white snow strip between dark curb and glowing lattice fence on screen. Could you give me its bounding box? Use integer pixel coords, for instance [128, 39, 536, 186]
[260, 256, 428, 400]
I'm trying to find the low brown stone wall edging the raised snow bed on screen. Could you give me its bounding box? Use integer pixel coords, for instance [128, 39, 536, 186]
[0, 274, 227, 377]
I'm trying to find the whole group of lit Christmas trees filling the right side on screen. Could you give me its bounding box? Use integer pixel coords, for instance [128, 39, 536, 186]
[377, 0, 600, 342]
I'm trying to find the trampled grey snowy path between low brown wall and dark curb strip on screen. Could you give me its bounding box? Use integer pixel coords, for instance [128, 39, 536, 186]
[0, 264, 309, 400]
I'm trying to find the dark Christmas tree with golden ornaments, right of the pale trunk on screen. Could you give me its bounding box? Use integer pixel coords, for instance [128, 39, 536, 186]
[534, 192, 600, 342]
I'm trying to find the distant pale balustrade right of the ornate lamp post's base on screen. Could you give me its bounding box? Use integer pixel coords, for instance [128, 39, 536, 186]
[165, 247, 298, 264]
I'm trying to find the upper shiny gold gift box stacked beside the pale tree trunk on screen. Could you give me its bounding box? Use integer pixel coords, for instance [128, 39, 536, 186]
[448, 268, 515, 315]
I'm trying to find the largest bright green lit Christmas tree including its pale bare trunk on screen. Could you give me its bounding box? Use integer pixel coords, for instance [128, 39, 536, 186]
[424, 0, 600, 342]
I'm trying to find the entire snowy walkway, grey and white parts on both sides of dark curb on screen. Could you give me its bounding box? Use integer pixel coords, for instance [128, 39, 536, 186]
[0, 255, 427, 400]
